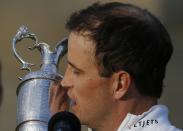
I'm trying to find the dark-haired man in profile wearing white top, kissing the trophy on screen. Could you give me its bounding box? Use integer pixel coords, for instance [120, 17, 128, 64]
[49, 2, 179, 131]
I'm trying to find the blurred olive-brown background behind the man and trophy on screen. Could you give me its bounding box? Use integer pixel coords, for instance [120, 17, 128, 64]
[0, 0, 183, 131]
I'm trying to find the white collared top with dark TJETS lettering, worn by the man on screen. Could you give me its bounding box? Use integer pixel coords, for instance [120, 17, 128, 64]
[117, 105, 182, 131]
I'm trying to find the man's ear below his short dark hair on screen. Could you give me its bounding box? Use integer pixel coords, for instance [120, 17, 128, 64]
[113, 71, 132, 100]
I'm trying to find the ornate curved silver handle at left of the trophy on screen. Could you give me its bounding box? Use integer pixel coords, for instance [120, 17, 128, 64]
[12, 25, 39, 71]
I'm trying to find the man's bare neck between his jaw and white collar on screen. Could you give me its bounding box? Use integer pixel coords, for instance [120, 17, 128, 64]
[94, 96, 157, 131]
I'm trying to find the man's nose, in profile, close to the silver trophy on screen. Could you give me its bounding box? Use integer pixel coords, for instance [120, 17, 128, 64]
[61, 68, 73, 89]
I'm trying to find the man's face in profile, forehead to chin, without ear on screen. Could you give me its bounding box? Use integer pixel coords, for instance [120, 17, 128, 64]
[61, 32, 116, 126]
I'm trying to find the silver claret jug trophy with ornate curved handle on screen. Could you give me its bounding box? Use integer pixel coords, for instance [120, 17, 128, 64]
[12, 26, 68, 131]
